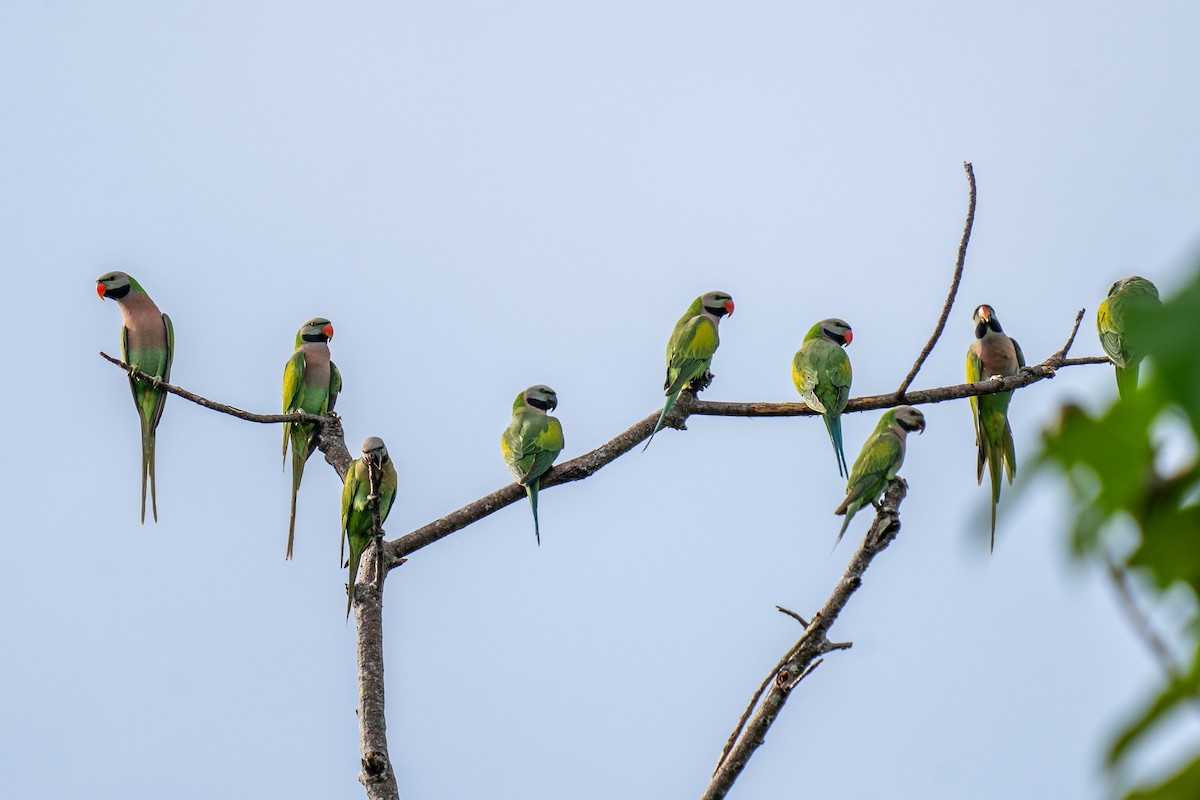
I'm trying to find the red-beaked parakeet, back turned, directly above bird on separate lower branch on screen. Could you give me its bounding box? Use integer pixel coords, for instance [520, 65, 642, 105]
[792, 317, 854, 477]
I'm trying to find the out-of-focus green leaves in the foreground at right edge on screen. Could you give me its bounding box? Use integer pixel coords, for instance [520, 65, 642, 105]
[1039, 271, 1200, 800]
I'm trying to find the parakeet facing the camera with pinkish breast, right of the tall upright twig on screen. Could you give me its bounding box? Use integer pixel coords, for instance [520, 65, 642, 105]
[967, 306, 1025, 549]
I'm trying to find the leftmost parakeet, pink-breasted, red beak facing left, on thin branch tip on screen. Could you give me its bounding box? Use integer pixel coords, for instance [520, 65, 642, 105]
[96, 272, 175, 524]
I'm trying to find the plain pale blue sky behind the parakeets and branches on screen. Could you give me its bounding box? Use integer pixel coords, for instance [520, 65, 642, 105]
[0, 2, 1200, 800]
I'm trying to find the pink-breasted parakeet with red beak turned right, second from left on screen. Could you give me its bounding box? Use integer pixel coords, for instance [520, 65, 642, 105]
[283, 317, 342, 559]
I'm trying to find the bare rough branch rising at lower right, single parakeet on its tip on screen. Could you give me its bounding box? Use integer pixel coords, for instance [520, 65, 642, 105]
[701, 476, 908, 800]
